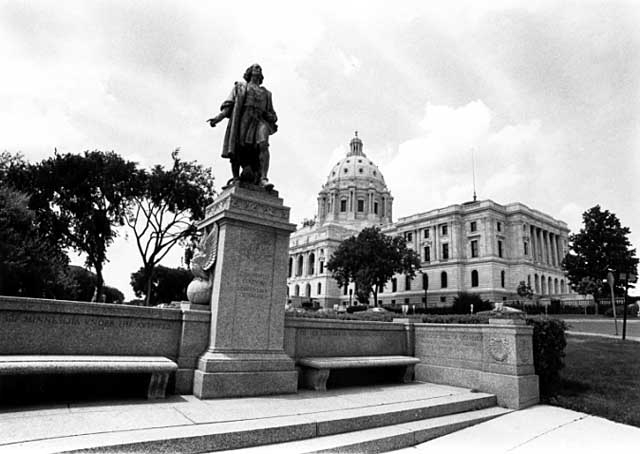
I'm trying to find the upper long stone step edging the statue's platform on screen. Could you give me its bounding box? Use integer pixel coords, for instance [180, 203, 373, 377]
[7, 392, 496, 453]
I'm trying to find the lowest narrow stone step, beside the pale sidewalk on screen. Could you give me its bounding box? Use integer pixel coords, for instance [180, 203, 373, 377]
[222, 407, 512, 454]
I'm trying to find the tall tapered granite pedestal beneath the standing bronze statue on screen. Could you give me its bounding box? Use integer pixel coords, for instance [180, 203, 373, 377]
[193, 185, 297, 399]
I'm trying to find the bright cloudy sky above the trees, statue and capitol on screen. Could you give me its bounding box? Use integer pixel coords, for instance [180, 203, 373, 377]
[0, 0, 640, 299]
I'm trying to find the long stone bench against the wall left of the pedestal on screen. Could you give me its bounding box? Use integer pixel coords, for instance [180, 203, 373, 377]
[0, 355, 178, 399]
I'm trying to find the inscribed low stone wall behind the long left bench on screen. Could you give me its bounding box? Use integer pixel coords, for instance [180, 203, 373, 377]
[0, 296, 211, 394]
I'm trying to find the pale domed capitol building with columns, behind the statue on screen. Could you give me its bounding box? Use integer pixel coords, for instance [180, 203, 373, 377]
[287, 134, 575, 307]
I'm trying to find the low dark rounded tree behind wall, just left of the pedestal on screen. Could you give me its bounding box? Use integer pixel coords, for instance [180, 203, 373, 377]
[131, 265, 193, 304]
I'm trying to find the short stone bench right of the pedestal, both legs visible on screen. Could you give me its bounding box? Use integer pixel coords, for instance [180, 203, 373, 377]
[296, 356, 420, 391]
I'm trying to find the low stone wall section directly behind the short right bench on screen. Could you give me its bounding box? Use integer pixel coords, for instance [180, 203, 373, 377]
[284, 318, 412, 359]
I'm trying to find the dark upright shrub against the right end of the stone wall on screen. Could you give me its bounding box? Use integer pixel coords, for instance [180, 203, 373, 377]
[527, 317, 567, 399]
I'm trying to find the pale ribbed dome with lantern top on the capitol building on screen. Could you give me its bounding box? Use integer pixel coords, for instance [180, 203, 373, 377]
[318, 132, 393, 229]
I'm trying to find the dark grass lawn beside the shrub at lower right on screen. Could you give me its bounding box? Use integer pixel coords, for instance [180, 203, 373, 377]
[549, 335, 640, 427]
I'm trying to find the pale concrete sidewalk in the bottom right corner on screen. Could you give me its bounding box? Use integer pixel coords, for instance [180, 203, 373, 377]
[393, 405, 640, 454]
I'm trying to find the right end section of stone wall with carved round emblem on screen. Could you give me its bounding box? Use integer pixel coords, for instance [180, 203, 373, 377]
[414, 319, 540, 409]
